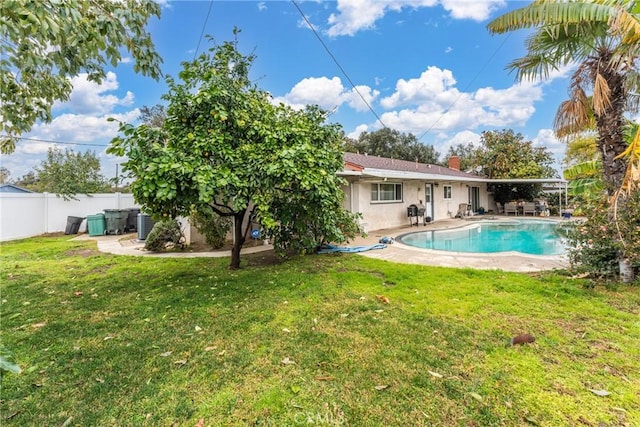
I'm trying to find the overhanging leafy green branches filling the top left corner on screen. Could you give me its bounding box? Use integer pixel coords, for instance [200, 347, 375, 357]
[0, 0, 161, 153]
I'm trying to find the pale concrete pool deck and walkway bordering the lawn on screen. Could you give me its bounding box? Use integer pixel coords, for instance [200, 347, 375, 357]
[76, 216, 569, 272]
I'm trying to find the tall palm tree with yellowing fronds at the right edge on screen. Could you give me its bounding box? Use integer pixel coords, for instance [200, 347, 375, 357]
[488, 0, 640, 195]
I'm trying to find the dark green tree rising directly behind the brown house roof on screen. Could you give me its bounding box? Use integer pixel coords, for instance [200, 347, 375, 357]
[344, 128, 440, 164]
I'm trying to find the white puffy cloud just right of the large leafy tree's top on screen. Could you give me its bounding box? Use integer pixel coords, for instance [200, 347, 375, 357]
[274, 77, 380, 111]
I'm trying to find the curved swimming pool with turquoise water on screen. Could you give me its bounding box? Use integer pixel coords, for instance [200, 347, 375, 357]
[397, 219, 566, 255]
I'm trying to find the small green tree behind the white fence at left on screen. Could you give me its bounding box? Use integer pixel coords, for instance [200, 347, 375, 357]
[34, 148, 109, 200]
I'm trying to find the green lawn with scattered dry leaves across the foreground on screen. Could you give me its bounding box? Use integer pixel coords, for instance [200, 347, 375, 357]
[0, 237, 640, 426]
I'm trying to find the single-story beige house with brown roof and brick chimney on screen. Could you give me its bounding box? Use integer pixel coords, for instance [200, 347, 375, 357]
[338, 153, 494, 231]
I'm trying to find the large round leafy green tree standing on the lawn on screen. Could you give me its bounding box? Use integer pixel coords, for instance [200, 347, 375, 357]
[109, 35, 357, 268]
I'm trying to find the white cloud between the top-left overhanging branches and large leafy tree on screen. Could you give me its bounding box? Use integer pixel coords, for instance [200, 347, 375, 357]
[54, 71, 134, 114]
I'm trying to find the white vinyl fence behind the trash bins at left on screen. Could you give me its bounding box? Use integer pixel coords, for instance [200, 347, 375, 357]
[0, 193, 139, 242]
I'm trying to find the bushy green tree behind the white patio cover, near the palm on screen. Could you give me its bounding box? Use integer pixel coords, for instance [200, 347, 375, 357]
[472, 129, 557, 203]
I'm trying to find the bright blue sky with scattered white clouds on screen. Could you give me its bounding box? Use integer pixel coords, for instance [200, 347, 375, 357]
[0, 0, 571, 180]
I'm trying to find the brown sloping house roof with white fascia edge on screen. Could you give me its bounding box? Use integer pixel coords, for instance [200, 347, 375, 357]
[343, 153, 486, 181]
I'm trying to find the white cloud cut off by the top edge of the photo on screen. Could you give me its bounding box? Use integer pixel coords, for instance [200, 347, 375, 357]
[327, 0, 506, 37]
